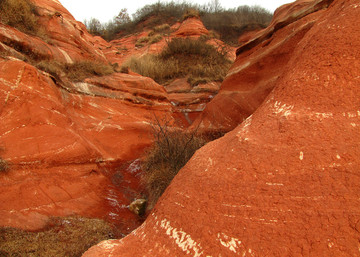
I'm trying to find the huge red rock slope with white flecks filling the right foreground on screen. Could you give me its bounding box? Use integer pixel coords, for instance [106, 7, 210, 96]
[83, 0, 360, 254]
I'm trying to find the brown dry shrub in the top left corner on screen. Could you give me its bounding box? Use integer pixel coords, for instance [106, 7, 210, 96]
[0, 0, 39, 35]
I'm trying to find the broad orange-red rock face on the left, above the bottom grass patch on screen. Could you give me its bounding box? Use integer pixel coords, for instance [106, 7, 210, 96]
[0, 59, 171, 232]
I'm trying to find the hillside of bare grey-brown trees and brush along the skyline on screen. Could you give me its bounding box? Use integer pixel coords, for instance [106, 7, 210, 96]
[85, 1, 272, 45]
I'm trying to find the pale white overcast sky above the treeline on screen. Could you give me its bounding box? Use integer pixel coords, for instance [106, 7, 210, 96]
[60, 0, 294, 23]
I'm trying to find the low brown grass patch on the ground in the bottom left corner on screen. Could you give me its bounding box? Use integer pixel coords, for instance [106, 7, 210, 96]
[0, 217, 114, 257]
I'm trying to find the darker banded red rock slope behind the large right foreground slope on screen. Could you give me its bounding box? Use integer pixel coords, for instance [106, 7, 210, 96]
[197, 0, 332, 131]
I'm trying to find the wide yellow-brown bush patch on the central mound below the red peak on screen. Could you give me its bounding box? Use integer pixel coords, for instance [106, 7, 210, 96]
[124, 38, 231, 85]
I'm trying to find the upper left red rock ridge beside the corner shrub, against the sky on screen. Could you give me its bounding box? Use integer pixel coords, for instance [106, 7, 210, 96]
[0, 0, 106, 63]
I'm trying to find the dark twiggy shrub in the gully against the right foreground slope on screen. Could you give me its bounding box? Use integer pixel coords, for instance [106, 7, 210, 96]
[142, 119, 206, 209]
